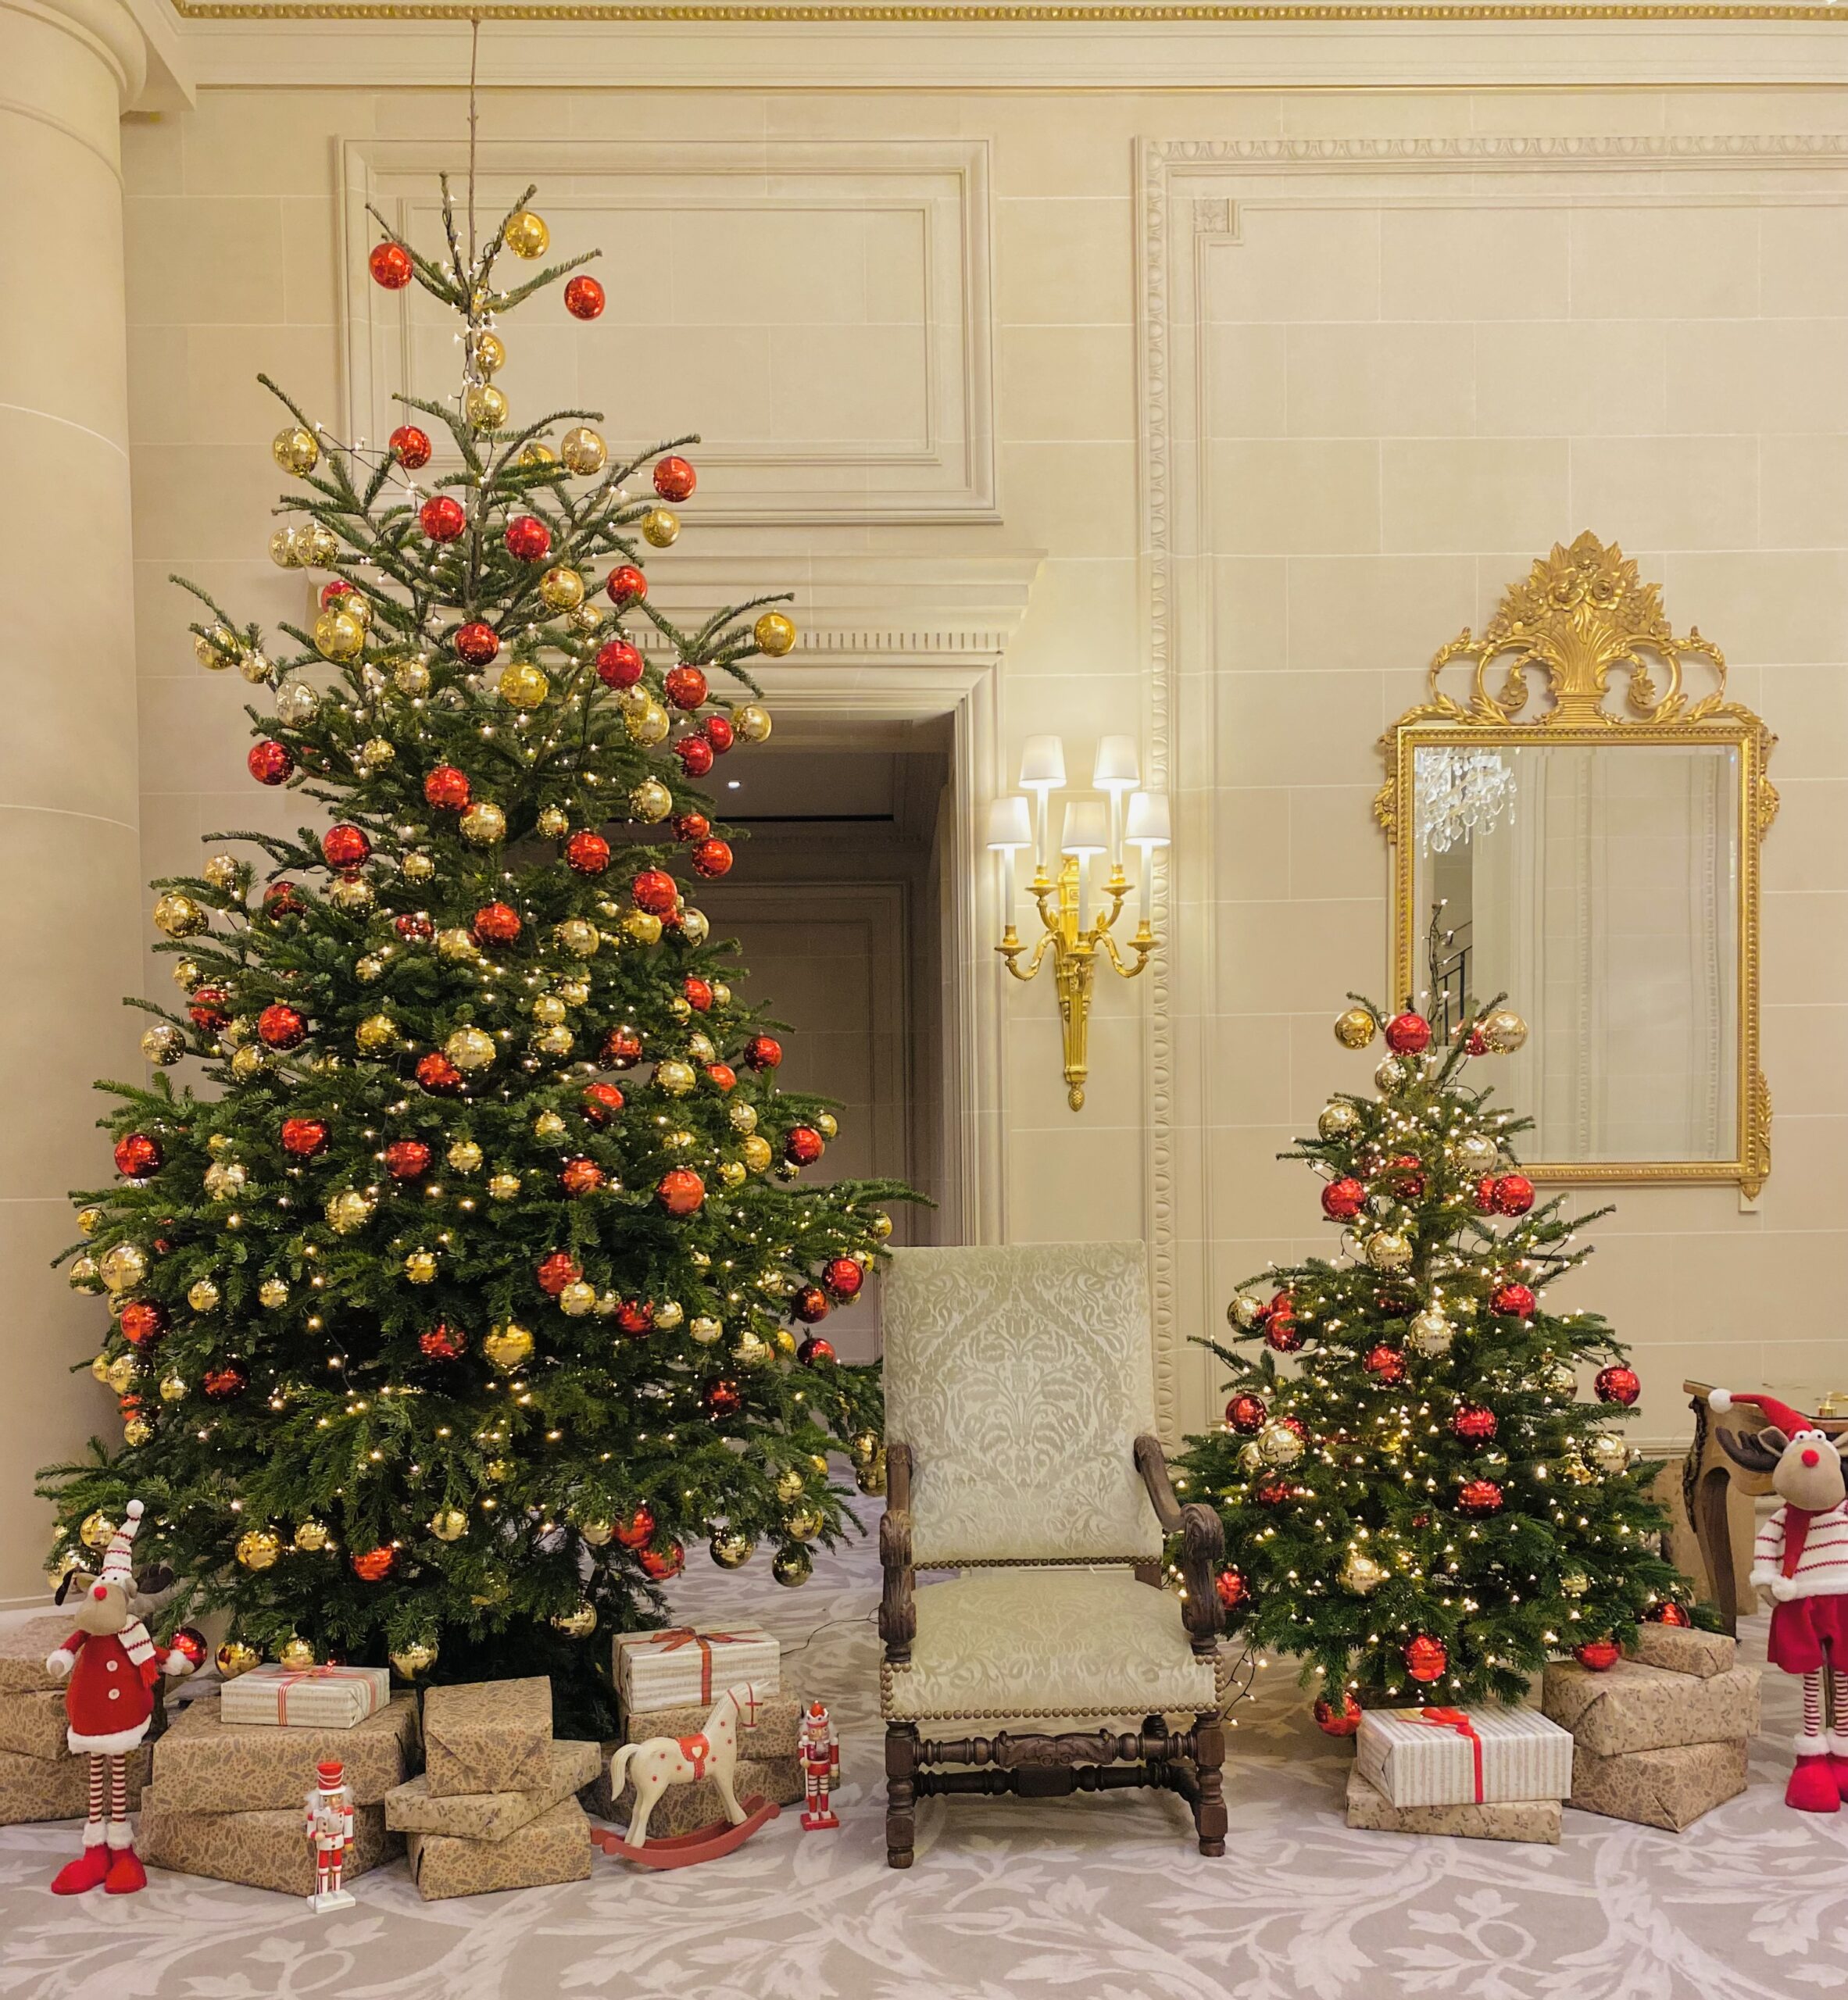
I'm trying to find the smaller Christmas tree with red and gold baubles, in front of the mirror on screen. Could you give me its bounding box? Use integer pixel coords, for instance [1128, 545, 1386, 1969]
[1188, 1002, 1688, 1734]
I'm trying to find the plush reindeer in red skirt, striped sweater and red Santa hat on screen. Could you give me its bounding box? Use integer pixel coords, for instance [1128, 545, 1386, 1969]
[1708, 1388, 1848, 1812]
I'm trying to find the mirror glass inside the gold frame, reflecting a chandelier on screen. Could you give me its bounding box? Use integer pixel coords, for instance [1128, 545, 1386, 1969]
[1406, 730, 1742, 1166]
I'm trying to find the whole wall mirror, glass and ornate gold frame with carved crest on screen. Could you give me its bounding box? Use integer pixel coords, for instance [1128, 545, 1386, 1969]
[1374, 534, 1778, 1196]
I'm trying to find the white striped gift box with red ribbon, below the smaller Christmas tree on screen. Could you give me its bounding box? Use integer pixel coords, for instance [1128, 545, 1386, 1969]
[1354, 1706, 1572, 1806]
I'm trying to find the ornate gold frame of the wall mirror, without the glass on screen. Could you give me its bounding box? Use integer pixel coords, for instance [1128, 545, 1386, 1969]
[1374, 534, 1778, 1200]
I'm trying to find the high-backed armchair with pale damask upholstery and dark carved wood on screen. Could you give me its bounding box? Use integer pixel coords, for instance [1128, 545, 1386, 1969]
[880, 1244, 1226, 1868]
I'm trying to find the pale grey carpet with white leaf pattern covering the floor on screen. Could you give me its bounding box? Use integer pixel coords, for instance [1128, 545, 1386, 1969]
[0, 1512, 1848, 2000]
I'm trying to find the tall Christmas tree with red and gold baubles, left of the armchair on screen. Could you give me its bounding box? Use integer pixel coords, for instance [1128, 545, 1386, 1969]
[46, 188, 906, 1720]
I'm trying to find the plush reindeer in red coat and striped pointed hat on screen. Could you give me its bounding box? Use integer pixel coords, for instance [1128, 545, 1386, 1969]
[44, 1500, 192, 1896]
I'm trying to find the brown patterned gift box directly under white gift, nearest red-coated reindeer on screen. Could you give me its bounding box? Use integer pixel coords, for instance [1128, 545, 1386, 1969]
[154, 1694, 418, 1814]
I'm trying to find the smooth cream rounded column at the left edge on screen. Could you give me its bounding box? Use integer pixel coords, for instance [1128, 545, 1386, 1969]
[0, 0, 146, 1610]
